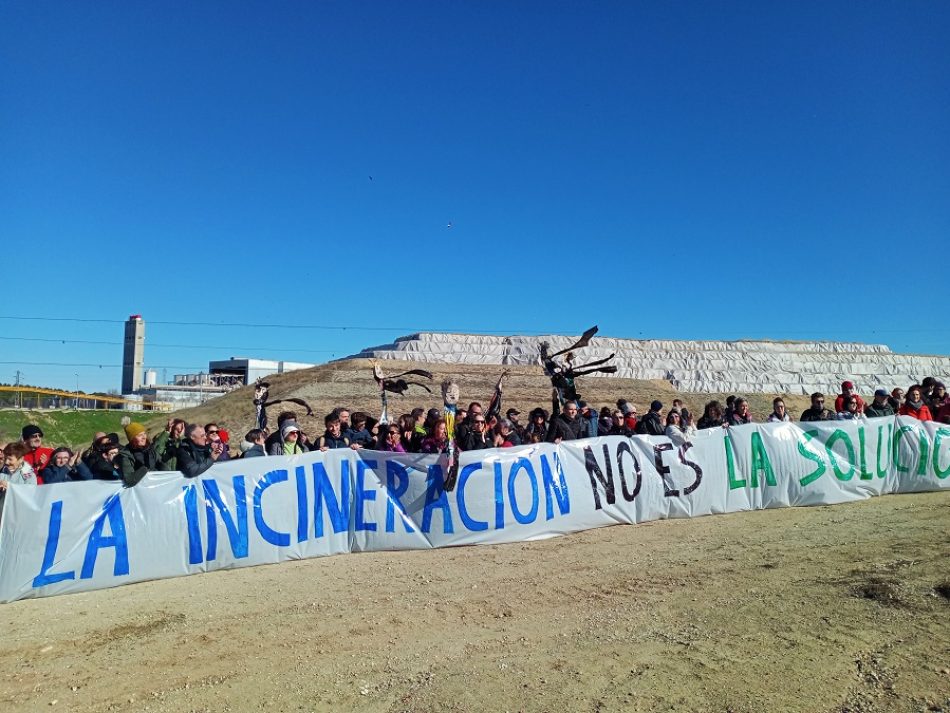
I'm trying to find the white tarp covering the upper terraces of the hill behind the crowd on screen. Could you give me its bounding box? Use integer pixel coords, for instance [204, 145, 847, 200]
[354, 332, 950, 394]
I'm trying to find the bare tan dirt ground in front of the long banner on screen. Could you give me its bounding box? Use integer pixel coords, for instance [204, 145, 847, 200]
[0, 492, 950, 712]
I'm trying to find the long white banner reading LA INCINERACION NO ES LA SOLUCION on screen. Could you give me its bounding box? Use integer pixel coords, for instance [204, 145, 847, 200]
[0, 417, 950, 602]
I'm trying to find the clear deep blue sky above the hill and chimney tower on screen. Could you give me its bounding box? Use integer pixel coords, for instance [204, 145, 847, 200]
[0, 0, 950, 390]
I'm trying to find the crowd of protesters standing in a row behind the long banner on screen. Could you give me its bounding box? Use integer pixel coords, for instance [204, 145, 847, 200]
[0, 377, 950, 502]
